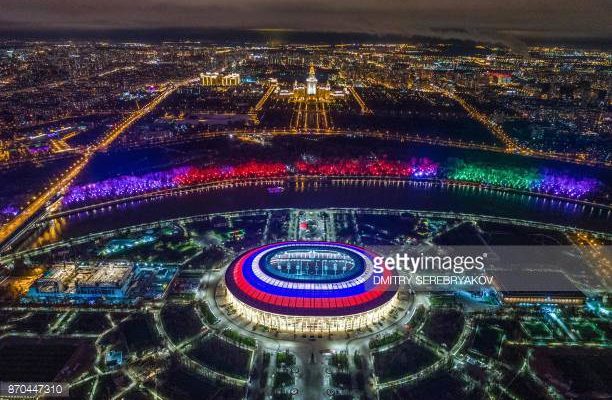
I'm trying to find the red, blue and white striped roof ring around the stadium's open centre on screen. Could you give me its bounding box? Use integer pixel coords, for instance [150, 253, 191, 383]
[225, 241, 397, 316]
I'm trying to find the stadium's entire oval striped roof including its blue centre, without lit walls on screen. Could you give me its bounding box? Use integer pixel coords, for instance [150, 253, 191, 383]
[225, 242, 397, 316]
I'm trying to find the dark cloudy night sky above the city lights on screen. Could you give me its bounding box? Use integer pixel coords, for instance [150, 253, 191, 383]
[0, 0, 612, 45]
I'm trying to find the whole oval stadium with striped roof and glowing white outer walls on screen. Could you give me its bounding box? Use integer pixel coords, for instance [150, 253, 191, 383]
[225, 242, 397, 332]
